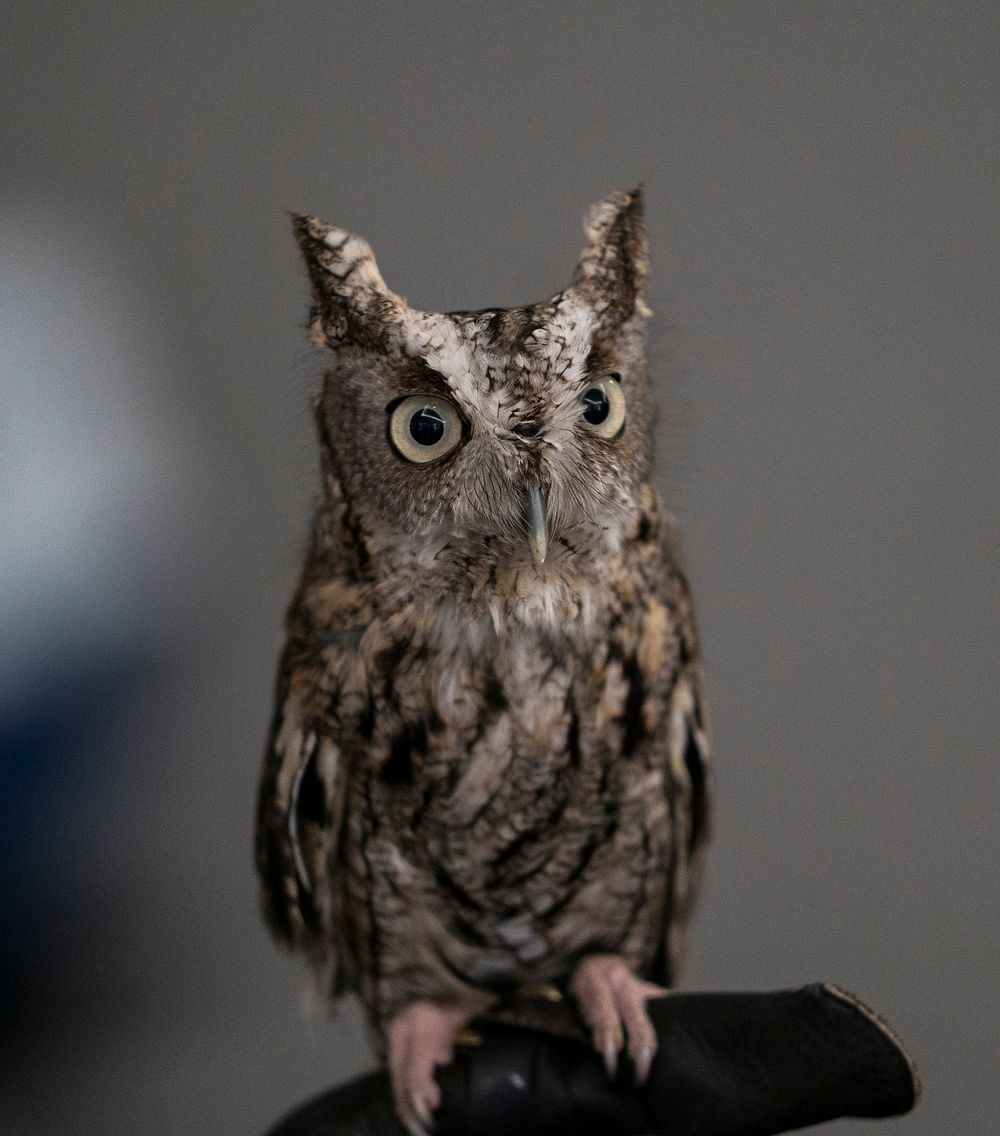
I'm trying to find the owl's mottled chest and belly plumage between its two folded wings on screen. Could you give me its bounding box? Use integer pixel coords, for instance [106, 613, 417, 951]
[347, 600, 676, 979]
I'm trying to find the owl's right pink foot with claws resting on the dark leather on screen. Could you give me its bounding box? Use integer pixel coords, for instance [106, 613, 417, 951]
[569, 954, 667, 1085]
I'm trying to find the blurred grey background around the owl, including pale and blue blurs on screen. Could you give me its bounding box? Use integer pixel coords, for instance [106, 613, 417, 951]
[0, 0, 1000, 1136]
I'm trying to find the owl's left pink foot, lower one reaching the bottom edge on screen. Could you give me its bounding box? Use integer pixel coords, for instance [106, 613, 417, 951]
[389, 1000, 490, 1136]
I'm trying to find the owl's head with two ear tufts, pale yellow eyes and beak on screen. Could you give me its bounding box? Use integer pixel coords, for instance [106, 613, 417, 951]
[294, 190, 650, 608]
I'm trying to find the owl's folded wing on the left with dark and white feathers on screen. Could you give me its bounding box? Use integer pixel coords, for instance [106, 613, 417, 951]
[257, 648, 347, 993]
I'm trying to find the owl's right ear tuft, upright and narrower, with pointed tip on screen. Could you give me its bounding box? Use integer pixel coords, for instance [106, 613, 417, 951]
[572, 186, 649, 323]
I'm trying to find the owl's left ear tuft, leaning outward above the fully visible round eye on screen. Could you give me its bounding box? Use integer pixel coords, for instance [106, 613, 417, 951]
[292, 214, 407, 350]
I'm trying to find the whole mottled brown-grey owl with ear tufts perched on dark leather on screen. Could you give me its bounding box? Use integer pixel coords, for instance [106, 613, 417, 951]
[257, 190, 709, 1133]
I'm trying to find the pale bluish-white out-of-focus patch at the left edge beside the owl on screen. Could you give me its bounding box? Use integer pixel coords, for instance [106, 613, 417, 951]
[0, 202, 195, 698]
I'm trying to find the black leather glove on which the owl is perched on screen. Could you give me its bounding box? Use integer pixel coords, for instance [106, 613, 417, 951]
[261, 984, 919, 1136]
